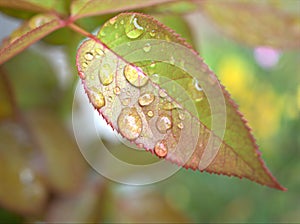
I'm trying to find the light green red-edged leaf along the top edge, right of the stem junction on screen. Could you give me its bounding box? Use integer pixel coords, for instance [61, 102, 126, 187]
[71, 0, 175, 20]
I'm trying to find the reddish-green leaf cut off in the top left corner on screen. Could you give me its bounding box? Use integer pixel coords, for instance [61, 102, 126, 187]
[0, 0, 67, 13]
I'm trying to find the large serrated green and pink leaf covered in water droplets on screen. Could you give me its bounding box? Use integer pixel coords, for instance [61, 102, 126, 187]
[77, 13, 284, 190]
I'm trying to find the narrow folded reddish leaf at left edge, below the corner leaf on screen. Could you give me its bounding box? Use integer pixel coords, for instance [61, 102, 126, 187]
[0, 14, 64, 65]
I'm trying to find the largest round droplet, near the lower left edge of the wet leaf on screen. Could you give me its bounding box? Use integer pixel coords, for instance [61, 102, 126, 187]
[118, 107, 142, 140]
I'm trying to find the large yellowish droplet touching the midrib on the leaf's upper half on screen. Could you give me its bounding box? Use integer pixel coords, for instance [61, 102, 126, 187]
[124, 64, 149, 87]
